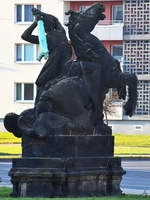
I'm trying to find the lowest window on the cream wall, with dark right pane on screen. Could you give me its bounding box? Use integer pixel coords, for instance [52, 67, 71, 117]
[15, 83, 36, 101]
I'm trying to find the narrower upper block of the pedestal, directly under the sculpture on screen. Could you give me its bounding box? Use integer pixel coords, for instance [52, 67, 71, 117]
[22, 135, 114, 158]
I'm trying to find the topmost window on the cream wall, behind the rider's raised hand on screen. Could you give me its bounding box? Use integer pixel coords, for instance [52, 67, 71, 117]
[16, 4, 41, 23]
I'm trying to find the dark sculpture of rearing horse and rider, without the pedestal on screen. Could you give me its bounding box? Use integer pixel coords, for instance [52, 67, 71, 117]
[4, 3, 137, 137]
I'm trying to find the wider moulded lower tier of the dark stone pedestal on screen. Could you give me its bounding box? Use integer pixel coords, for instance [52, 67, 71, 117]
[9, 157, 125, 197]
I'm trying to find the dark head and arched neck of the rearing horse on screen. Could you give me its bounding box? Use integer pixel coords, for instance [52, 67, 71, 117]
[66, 3, 116, 69]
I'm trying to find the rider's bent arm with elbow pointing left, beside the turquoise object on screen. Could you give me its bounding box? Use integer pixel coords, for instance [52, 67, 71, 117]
[21, 21, 39, 44]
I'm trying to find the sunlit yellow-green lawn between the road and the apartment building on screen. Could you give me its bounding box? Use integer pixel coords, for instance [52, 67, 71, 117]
[0, 133, 150, 158]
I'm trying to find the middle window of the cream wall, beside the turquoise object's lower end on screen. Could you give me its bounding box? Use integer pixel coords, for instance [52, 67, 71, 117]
[16, 44, 39, 62]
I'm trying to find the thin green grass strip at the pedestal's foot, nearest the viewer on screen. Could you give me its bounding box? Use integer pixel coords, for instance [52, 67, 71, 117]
[0, 187, 150, 200]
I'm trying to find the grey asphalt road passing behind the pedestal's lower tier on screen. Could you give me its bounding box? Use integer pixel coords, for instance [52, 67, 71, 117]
[0, 161, 150, 194]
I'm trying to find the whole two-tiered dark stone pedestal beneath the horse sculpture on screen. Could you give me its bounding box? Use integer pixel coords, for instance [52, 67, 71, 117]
[9, 136, 124, 197]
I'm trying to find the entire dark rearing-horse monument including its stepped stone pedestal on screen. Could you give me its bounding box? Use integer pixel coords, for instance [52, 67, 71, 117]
[4, 3, 137, 197]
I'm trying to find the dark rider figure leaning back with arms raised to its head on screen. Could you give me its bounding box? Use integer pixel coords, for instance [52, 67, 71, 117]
[21, 8, 71, 104]
